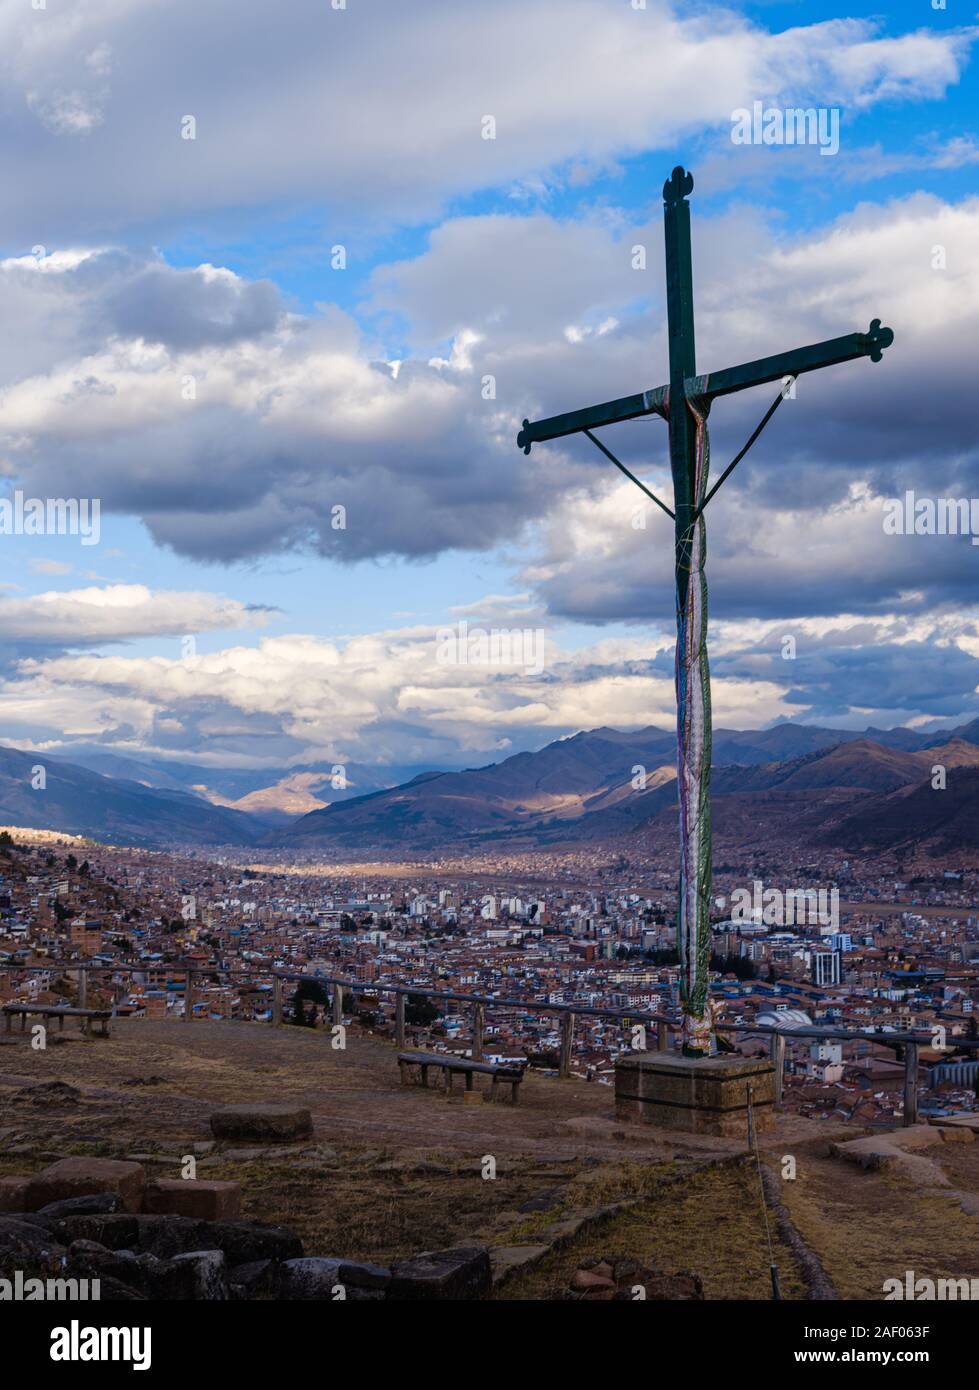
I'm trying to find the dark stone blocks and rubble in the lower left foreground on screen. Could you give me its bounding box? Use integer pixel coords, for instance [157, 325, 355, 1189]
[0, 1145, 492, 1301]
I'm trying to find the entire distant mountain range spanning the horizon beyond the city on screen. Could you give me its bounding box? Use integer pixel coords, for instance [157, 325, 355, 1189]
[0, 720, 979, 855]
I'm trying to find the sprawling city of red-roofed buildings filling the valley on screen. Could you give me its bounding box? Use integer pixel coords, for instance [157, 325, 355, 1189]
[0, 833, 979, 1122]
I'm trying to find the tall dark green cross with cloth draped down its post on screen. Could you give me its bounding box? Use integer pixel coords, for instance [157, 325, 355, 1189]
[517, 167, 894, 1056]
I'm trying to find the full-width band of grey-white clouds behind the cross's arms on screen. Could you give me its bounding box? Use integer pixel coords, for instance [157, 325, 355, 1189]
[0, 195, 979, 592]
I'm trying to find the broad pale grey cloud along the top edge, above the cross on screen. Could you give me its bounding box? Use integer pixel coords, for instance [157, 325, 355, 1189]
[0, 0, 971, 239]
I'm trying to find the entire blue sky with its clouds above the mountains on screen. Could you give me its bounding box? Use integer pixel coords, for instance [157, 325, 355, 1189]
[0, 0, 979, 767]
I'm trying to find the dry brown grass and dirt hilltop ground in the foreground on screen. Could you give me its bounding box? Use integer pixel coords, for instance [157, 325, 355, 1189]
[0, 1020, 979, 1298]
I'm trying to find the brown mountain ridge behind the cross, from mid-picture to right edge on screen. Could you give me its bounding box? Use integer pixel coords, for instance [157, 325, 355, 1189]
[274, 720, 979, 851]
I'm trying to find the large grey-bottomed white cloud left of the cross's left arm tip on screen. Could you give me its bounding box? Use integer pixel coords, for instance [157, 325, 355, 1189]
[0, 252, 589, 560]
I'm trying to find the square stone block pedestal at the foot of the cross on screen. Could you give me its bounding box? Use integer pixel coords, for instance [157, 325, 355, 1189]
[615, 1052, 775, 1138]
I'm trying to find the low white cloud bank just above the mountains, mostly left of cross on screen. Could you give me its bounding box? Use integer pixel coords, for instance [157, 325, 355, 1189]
[0, 626, 788, 765]
